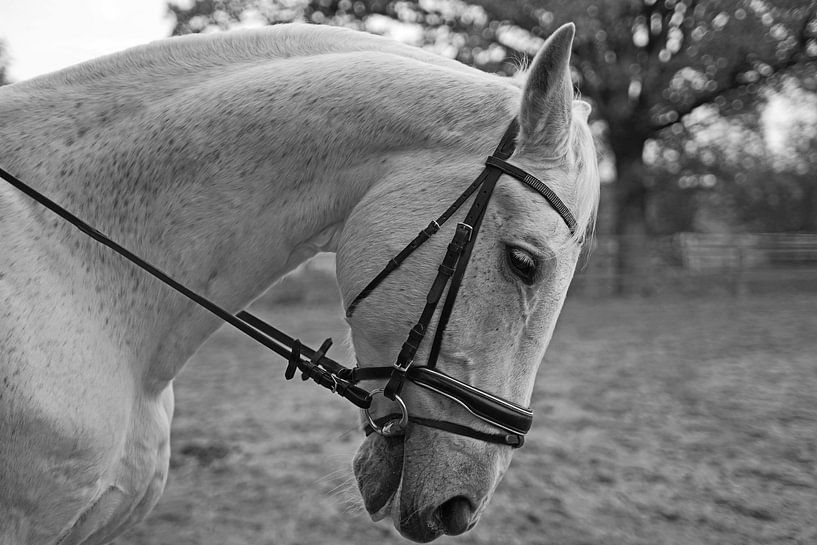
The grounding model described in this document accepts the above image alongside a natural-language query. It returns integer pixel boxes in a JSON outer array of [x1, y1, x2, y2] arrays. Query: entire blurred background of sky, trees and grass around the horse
[[0, 0, 817, 545]]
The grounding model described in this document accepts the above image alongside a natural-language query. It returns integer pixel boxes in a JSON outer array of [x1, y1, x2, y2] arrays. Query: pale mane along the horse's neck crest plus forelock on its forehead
[[13, 23, 599, 242]]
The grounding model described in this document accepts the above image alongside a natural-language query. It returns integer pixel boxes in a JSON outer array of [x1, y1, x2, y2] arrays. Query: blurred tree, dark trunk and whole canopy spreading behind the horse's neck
[[170, 0, 817, 292]]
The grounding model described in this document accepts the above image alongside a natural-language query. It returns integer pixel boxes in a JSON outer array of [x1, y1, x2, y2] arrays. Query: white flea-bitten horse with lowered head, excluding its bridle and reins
[[0, 24, 599, 545]]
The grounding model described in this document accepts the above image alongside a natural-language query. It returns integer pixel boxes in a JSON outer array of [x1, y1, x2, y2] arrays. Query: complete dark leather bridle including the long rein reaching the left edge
[[0, 120, 576, 448]]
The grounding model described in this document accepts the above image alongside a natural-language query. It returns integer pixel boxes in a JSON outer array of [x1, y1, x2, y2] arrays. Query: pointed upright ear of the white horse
[[519, 23, 576, 147]]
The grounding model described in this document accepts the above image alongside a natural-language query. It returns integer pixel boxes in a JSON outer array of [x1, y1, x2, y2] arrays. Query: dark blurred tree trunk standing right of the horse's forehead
[[610, 134, 654, 295]]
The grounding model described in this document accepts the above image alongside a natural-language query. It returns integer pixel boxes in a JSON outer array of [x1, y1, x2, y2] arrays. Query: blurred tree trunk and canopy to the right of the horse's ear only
[[540, 0, 817, 291]]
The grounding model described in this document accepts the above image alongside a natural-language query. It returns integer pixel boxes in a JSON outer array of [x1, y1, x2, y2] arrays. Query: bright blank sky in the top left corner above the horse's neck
[[0, 0, 173, 81]]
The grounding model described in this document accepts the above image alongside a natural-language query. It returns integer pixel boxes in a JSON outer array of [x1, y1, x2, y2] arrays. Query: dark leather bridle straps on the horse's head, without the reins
[[338, 119, 576, 447]]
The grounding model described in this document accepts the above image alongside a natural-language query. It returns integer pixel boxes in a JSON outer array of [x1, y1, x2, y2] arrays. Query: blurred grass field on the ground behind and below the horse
[[118, 274, 817, 545]]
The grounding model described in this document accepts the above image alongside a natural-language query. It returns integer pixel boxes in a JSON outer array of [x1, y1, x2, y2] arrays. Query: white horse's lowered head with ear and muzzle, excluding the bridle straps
[[337, 25, 598, 542]]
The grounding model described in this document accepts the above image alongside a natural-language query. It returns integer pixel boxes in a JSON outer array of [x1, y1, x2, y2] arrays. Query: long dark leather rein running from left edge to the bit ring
[[0, 167, 372, 409]]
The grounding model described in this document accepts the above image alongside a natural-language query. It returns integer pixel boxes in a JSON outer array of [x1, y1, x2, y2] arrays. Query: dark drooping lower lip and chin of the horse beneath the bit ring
[[352, 433, 405, 521]]
